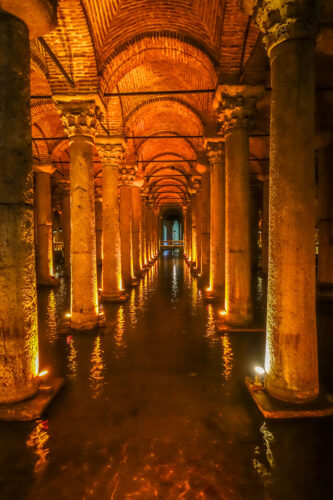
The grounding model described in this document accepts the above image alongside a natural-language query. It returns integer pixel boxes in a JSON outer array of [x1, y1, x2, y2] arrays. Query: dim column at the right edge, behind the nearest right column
[[318, 147, 333, 292]]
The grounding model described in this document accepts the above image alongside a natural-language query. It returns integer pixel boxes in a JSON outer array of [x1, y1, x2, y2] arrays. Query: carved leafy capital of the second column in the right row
[[213, 85, 264, 134]]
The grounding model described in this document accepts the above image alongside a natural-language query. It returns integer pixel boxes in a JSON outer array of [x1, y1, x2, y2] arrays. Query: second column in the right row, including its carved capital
[[215, 85, 262, 326]]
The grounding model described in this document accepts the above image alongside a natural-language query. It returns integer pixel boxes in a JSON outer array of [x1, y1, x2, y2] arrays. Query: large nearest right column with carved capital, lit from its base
[[254, 0, 319, 403]]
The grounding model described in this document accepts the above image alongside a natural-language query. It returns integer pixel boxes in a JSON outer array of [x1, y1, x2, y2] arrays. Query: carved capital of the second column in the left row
[[55, 96, 103, 141]]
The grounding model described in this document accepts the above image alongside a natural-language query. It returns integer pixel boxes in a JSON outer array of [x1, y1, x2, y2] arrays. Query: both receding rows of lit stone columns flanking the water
[[0, 1, 333, 412]]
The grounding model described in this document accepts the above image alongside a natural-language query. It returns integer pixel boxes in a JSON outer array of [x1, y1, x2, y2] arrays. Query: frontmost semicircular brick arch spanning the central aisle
[[101, 32, 217, 93]]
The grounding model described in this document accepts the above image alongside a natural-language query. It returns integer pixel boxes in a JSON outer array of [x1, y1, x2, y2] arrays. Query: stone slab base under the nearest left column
[[0, 377, 64, 422]]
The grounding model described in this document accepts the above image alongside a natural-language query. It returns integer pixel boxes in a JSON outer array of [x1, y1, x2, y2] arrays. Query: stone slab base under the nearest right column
[[245, 377, 333, 419]]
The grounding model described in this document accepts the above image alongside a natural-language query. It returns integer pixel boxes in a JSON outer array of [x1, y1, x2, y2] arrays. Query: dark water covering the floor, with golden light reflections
[[0, 252, 333, 500]]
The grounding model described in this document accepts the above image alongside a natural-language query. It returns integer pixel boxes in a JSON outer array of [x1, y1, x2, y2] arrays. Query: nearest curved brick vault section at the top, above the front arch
[[82, 0, 223, 71]]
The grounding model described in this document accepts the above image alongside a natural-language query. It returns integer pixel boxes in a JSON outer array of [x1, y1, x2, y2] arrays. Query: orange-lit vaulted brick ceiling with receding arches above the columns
[[31, 0, 332, 211]]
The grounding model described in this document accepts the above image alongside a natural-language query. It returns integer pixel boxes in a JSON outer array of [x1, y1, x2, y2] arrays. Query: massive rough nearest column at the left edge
[[0, 2, 55, 403]]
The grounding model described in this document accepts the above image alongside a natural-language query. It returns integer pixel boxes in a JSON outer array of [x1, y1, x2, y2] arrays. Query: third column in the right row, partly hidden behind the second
[[207, 140, 225, 296]]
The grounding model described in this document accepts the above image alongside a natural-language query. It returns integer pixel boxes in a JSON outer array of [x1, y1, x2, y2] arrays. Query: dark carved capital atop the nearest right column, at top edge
[[253, 0, 320, 55]]
